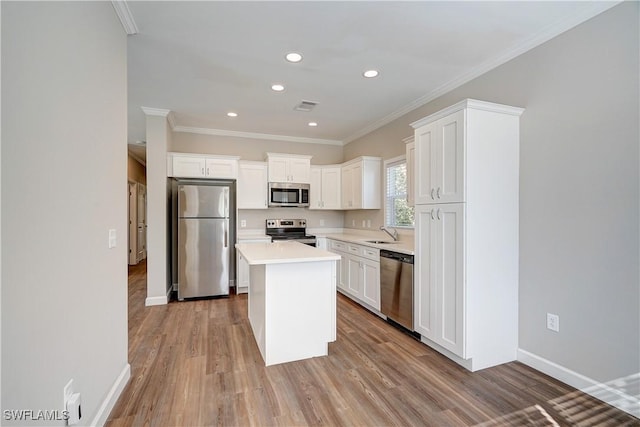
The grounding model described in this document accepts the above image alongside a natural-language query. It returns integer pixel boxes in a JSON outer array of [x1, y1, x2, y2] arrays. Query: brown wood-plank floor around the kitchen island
[[107, 264, 640, 427]]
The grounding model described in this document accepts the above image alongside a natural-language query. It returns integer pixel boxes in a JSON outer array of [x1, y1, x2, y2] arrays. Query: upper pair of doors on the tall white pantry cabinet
[[415, 110, 466, 204]]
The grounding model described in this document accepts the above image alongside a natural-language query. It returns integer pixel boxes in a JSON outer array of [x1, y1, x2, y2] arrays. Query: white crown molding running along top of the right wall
[[344, 1, 622, 145]]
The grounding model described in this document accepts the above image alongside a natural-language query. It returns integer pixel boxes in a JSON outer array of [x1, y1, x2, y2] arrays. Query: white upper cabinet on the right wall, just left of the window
[[342, 157, 382, 209]]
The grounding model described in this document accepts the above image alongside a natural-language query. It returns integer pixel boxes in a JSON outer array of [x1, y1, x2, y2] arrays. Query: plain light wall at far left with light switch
[[1, 2, 129, 425]]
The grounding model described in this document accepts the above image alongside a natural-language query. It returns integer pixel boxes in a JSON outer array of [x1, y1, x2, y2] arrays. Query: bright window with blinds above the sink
[[384, 156, 413, 227]]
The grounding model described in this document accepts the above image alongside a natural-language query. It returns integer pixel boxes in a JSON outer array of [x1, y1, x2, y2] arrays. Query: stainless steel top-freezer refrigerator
[[177, 182, 235, 301]]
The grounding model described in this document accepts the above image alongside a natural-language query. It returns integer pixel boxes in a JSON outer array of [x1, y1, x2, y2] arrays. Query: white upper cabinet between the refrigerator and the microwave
[[237, 160, 268, 209]]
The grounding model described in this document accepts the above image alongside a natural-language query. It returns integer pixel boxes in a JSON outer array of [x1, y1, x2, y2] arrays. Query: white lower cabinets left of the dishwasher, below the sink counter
[[329, 239, 380, 310]]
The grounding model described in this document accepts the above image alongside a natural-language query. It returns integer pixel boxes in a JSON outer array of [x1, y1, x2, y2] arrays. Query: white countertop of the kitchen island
[[236, 240, 340, 265]]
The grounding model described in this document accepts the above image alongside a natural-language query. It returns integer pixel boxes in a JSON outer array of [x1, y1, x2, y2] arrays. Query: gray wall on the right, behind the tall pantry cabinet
[[345, 2, 640, 382]]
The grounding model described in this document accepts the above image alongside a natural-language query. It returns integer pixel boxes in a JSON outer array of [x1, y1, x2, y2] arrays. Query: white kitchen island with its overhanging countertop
[[231, 241, 340, 366]]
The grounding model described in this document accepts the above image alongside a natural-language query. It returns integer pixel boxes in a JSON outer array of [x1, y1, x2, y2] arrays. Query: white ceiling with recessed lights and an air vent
[[127, 1, 616, 159]]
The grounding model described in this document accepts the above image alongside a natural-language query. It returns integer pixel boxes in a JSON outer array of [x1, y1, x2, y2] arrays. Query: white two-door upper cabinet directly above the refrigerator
[[167, 153, 239, 179]]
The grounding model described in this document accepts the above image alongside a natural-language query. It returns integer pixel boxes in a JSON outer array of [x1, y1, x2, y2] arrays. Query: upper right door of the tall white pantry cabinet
[[434, 110, 466, 203]]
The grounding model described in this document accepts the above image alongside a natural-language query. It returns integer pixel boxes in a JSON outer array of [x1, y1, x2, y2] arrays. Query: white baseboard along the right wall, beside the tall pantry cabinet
[[518, 349, 640, 418]]
